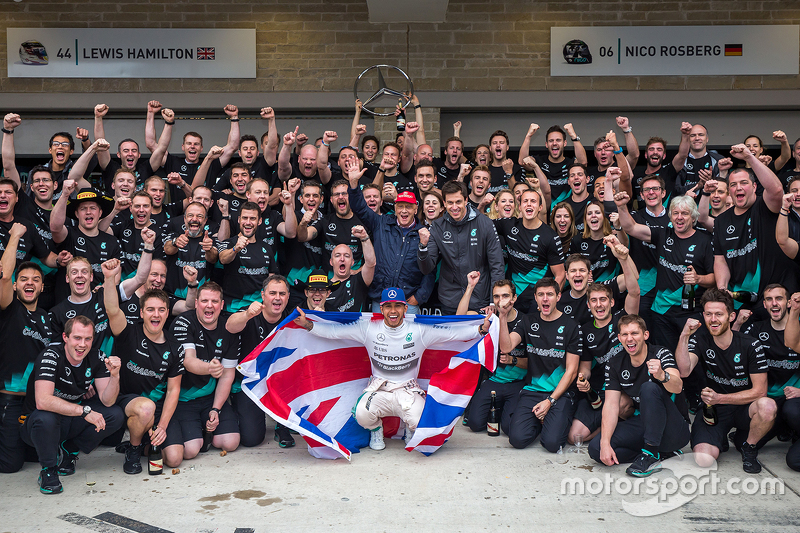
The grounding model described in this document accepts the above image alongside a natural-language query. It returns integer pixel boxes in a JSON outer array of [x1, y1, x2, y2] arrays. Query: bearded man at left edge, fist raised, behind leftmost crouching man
[[0, 227, 52, 473]]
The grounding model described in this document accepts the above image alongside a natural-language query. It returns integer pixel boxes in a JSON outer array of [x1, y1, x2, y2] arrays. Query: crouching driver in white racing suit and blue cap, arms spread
[[295, 287, 491, 450]]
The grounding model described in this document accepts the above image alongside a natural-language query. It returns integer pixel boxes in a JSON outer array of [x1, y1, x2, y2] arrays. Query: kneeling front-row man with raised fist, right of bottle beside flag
[[497, 278, 583, 453]]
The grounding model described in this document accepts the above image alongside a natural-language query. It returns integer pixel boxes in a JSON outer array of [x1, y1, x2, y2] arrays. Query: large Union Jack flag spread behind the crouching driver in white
[[239, 310, 499, 460]]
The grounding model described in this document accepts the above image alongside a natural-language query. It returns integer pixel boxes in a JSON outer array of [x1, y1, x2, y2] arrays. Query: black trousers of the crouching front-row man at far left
[[20, 396, 125, 468]]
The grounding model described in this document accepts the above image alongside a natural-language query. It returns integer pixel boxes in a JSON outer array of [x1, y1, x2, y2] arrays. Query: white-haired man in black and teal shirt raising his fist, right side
[[614, 192, 716, 353]]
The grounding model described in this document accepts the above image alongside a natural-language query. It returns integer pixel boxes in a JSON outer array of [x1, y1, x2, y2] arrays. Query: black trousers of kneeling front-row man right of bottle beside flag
[[508, 389, 576, 453]]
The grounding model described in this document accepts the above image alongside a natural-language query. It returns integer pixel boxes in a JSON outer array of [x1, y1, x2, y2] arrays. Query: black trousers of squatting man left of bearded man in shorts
[[589, 381, 689, 463]]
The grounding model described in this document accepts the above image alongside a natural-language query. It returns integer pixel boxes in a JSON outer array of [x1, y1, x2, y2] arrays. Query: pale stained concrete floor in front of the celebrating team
[[0, 424, 800, 533]]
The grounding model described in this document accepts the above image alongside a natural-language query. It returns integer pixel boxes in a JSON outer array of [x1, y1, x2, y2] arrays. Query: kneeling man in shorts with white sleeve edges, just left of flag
[[169, 281, 239, 466]]
